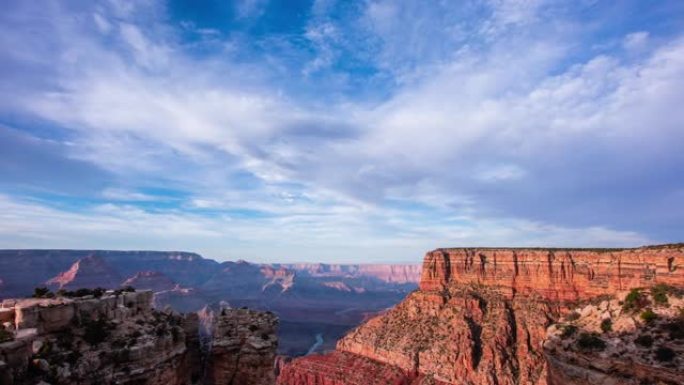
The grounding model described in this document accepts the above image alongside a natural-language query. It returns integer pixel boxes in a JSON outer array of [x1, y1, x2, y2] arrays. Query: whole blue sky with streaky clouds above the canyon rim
[[0, 0, 684, 263]]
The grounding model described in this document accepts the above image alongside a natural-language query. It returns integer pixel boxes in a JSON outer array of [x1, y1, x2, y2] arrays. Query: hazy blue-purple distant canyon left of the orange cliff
[[0, 250, 421, 356]]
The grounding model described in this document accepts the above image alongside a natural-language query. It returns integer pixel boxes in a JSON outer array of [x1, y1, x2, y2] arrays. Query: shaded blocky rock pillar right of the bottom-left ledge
[[204, 309, 278, 385]]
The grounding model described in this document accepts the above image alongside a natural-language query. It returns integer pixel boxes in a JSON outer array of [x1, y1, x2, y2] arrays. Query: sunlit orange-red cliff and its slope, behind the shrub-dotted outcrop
[[279, 245, 684, 385]]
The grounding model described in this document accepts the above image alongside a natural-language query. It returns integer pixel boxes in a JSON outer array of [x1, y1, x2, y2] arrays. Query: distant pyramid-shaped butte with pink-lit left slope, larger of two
[[45, 254, 121, 290]]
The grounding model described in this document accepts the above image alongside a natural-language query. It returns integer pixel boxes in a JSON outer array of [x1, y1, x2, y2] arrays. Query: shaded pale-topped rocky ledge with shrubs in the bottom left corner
[[0, 291, 193, 385]]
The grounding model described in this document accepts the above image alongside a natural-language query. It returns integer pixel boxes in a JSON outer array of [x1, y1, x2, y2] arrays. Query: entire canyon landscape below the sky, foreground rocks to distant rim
[[0, 244, 684, 385]]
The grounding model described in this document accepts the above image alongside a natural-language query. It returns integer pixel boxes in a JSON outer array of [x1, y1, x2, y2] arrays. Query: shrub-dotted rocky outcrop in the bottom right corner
[[544, 286, 684, 385]]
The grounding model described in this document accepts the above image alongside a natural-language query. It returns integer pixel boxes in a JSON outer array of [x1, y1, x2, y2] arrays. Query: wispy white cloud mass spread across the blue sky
[[0, 1, 684, 258]]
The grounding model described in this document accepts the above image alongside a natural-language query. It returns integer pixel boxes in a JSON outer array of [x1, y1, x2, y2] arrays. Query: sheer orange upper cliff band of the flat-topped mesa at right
[[420, 244, 684, 301]]
